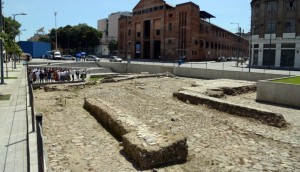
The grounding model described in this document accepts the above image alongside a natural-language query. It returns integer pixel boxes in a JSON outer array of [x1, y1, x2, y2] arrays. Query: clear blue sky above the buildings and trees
[[2, 0, 250, 41]]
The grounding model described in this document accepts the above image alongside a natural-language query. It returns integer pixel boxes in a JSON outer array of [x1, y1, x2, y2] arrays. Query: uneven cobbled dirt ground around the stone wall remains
[[34, 77, 300, 172]]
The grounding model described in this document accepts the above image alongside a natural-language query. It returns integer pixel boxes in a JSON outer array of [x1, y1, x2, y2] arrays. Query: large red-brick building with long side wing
[[118, 0, 249, 61]]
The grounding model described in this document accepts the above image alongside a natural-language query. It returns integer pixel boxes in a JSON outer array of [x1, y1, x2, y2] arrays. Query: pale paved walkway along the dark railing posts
[[0, 64, 37, 172]]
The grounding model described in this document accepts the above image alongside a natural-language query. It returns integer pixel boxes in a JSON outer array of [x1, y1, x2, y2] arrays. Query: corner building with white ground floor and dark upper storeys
[[251, 0, 300, 68]]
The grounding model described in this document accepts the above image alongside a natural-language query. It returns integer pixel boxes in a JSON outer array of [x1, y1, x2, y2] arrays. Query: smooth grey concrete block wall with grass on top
[[256, 77, 300, 108]]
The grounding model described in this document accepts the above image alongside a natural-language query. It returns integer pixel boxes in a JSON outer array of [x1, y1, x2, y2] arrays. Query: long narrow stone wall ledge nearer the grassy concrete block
[[173, 91, 287, 128]]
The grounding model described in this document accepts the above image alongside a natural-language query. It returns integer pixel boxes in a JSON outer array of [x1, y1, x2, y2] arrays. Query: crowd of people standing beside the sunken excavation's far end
[[28, 68, 86, 83]]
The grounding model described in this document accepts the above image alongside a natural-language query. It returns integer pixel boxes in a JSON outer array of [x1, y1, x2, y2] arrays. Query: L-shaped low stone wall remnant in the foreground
[[84, 99, 188, 170]]
